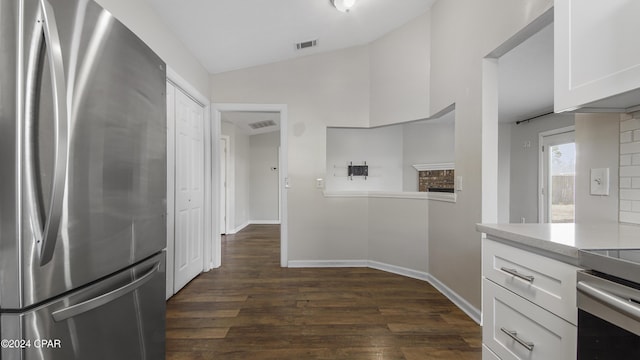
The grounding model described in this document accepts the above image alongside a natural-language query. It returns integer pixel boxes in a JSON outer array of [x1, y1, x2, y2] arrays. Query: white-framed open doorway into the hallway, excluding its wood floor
[[212, 104, 288, 267]]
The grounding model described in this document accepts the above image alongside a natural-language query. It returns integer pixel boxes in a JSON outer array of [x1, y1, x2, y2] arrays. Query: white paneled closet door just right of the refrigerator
[[174, 90, 204, 292]]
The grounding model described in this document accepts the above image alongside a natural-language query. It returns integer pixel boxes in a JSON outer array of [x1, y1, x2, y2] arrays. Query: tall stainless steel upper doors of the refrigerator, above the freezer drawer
[[0, 0, 166, 309]]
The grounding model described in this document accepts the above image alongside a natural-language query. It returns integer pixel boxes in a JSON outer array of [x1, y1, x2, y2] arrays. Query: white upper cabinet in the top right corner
[[554, 0, 640, 112]]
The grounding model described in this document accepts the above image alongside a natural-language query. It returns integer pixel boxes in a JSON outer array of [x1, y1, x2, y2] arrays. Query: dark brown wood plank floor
[[167, 225, 481, 360]]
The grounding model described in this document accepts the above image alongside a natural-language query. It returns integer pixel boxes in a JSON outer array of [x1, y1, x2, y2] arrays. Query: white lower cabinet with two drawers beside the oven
[[482, 239, 578, 360]]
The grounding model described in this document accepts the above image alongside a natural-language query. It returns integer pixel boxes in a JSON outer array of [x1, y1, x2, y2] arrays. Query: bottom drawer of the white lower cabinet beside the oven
[[482, 278, 577, 360]]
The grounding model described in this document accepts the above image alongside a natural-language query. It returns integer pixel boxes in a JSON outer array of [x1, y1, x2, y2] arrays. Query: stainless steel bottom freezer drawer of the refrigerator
[[0, 253, 165, 360]]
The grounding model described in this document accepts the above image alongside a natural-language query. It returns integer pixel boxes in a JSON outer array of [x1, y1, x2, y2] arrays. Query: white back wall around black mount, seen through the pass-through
[[326, 126, 402, 191]]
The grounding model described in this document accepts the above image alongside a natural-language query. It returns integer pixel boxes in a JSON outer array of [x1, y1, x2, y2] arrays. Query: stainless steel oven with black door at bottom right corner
[[577, 249, 640, 360]]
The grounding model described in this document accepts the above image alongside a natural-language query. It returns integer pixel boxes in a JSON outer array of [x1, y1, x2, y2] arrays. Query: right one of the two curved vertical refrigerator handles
[[34, 0, 68, 266]]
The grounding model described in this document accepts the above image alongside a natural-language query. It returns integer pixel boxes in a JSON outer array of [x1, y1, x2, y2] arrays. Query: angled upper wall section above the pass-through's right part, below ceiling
[[369, 12, 431, 126]]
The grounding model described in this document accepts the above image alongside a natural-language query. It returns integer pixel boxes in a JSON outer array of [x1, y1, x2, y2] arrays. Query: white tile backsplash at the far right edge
[[619, 112, 640, 224]]
